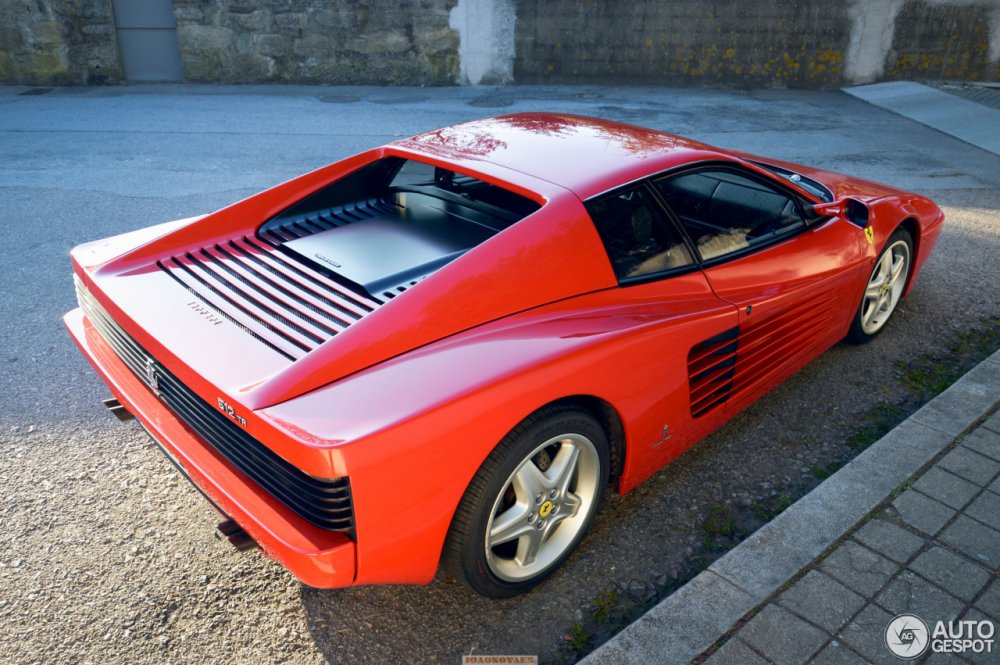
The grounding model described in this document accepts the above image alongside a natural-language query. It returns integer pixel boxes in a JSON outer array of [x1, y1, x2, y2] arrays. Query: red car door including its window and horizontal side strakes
[[654, 166, 869, 415]]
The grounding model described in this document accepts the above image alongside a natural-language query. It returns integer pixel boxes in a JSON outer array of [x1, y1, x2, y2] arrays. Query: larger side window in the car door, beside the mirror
[[655, 170, 805, 261]]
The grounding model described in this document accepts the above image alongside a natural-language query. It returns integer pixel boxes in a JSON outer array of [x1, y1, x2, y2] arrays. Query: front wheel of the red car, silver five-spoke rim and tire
[[847, 229, 913, 344]]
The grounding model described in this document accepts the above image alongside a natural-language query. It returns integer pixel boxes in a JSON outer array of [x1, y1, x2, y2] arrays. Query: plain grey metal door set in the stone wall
[[111, 0, 183, 81]]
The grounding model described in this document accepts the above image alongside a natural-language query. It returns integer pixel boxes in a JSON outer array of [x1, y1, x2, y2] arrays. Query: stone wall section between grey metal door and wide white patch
[[174, 0, 458, 85]]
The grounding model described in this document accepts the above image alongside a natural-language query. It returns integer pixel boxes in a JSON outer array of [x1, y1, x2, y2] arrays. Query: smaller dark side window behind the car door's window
[[587, 187, 693, 279]]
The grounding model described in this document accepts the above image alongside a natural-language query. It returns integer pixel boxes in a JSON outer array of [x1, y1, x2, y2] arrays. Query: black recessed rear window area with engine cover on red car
[[257, 157, 541, 300]]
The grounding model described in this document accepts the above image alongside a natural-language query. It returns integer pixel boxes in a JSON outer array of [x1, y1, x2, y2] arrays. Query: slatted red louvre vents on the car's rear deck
[[157, 236, 381, 360]]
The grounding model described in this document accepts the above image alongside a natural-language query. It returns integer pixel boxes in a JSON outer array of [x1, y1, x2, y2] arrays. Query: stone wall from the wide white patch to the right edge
[[513, 0, 1000, 88]]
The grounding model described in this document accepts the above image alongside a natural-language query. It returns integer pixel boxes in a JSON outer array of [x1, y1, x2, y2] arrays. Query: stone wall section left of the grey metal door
[[0, 0, 122, 85]]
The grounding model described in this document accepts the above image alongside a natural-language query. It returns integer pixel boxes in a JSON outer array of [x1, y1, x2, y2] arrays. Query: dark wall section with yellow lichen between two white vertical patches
[[514, 0, 851, 87]]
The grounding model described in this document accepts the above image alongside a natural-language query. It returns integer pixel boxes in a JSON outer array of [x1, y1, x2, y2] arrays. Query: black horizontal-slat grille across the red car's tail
[[76, 278, 354, 535]]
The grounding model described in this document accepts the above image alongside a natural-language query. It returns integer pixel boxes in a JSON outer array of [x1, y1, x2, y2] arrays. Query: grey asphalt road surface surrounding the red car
[[0, 86, 1000, 663]]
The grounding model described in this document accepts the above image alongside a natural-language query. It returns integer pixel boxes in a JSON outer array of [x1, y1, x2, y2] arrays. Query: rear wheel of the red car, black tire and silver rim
[[444, 405, 610, 598]]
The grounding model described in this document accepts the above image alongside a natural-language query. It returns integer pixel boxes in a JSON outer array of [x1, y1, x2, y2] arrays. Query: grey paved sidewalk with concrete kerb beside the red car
[[584, 352, 1000, 665]]
